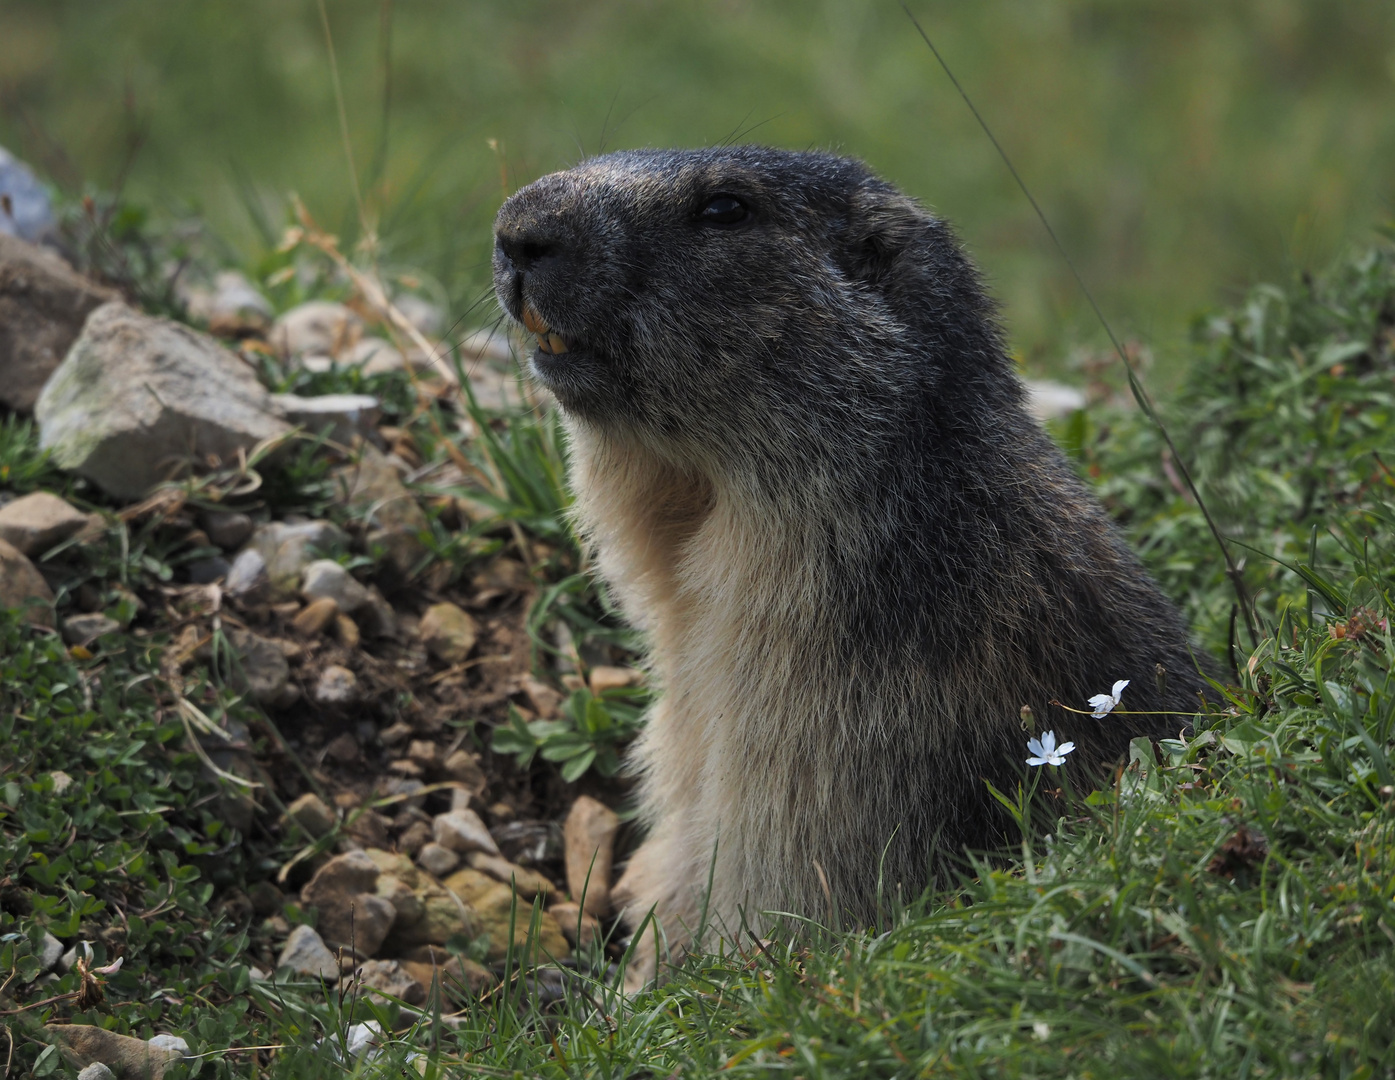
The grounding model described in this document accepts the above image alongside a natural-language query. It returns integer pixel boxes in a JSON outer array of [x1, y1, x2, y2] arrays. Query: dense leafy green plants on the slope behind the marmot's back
[[1057, 234, 1395, 650]]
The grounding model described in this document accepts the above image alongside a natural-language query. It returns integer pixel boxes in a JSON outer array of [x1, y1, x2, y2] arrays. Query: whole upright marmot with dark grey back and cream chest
[[494, 147, 1205, 974]]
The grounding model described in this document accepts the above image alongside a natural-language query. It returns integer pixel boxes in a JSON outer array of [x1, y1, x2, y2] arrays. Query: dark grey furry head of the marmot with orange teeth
[[494, 147, 1016, 460]]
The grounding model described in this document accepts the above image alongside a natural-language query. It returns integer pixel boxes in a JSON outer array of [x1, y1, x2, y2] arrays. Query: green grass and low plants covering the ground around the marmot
[[0, 196, 1395, 1080]]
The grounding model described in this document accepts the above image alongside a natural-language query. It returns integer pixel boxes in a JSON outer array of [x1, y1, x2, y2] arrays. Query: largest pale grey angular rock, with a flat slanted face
[[33, 303, 290, 498]]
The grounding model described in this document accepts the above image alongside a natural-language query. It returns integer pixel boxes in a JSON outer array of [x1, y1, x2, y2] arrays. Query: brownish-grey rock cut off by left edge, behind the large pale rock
[[0, 233, 119, 413]]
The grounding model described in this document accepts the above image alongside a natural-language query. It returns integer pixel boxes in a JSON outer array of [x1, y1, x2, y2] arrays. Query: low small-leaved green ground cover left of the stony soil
[[0, 613, 260, 1056]]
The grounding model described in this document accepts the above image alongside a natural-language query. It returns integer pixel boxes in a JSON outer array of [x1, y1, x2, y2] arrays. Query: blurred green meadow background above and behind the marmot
[[0, 0, 1395, 382]]
